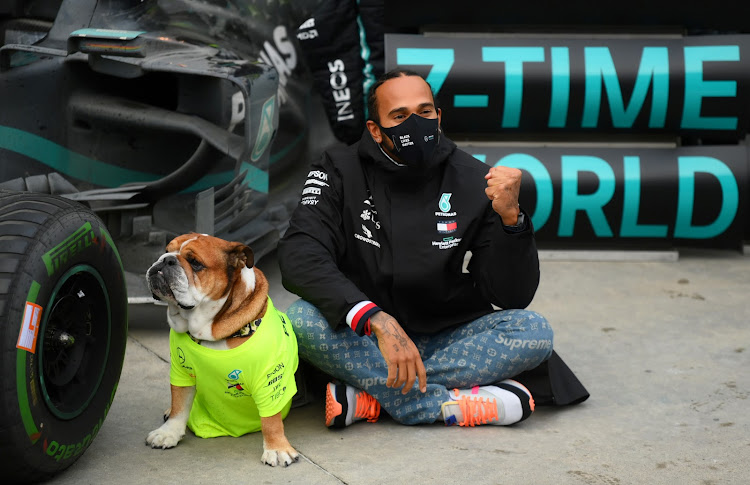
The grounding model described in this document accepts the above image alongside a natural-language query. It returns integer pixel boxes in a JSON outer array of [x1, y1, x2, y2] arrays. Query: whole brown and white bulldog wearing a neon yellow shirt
[[146, 234, 299, 466]]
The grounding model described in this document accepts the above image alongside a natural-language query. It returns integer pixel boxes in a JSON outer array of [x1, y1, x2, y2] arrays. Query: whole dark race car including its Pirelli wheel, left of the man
[[0, 0, 335, 481]]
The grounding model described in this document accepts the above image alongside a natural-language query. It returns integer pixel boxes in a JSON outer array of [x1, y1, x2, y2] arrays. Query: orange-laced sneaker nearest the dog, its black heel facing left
[[326, 382, 380, 428]]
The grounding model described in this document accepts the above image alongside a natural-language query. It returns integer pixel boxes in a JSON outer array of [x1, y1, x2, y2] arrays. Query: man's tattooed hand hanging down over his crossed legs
[[370, 311, 427, 394]]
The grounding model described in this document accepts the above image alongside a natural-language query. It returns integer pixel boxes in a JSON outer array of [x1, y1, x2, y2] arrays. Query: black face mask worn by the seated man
[[380, 114, 440, 169]]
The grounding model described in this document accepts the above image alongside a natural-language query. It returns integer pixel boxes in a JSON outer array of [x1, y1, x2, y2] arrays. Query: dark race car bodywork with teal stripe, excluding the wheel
[[0, 0, 334, 294]]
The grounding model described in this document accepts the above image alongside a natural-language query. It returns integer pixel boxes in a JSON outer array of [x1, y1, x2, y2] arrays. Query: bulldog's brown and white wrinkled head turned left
[[146, 233, 255, 340]]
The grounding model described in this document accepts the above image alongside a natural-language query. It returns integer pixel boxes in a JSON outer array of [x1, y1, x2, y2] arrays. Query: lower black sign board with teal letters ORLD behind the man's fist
[[461, 145, 748, 247]]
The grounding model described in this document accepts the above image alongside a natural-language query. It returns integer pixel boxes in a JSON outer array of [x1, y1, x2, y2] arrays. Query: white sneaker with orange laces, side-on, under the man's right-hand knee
[[441, 379, 534, 426]]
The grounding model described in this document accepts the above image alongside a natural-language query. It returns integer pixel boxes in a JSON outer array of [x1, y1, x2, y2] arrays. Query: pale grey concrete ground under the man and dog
[[51, 251, 750, 485]]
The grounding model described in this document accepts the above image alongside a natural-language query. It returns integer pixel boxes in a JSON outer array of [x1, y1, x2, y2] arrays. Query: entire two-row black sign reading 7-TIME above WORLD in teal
[[386, 34, 750, 248]]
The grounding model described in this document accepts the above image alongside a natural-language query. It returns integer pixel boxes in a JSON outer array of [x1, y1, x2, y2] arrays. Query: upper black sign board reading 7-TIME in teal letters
[[386, 34, 750, 140]]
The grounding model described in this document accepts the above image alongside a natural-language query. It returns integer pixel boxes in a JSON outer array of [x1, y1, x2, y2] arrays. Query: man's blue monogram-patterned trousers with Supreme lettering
[[286, 300, 553, 424]]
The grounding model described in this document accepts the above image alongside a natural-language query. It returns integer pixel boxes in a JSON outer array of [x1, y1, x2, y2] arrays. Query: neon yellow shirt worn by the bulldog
[[169, 298, 299, 438]]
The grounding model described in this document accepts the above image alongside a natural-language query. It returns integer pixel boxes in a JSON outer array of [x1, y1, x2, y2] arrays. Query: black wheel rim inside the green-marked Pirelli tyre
[[39, 265, 112, 419]]
